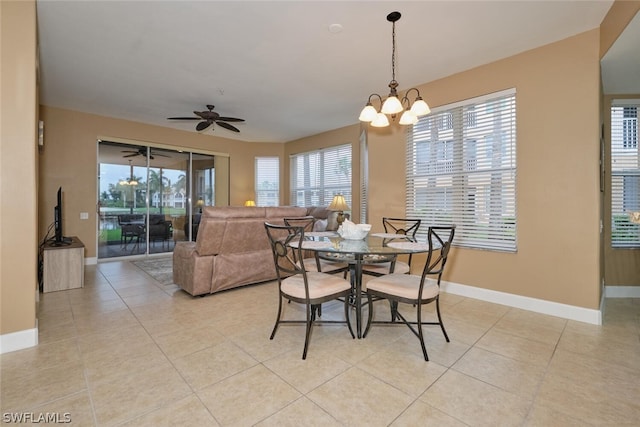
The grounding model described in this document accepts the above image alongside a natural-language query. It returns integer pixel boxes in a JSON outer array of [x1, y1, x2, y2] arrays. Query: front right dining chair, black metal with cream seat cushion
[[363, 225, 456, 361]]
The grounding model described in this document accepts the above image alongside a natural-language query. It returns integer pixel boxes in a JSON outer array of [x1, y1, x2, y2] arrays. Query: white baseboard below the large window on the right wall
[[441, 282, 602, 325]]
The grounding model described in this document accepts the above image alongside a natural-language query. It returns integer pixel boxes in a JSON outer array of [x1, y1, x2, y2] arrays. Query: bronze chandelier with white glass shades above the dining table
[[359, 12, 431, 127]]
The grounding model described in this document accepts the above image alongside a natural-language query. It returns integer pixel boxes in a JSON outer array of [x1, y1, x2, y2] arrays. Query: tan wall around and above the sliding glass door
[[38, 106, 283, 257]]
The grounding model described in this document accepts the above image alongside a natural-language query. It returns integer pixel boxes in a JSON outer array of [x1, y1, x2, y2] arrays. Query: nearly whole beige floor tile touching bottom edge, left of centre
[[197, 365, 301, 426]]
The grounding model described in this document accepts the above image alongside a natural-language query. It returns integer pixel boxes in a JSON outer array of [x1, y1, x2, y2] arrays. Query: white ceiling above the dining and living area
[[37, 0, 628, 142]]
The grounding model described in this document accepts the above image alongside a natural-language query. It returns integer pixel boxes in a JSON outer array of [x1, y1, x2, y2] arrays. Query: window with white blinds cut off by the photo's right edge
[[611, 100, 640, 248]]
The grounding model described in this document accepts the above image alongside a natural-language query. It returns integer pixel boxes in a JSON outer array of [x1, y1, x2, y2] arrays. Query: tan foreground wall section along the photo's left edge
[[0, 1, 38, 335]]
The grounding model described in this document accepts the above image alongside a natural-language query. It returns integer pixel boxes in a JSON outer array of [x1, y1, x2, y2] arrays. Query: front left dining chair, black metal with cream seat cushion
[[264, 223, 355, 360]]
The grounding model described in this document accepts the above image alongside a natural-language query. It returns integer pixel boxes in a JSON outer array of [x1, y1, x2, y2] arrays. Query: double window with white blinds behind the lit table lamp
[[290, 144, 352, 206]]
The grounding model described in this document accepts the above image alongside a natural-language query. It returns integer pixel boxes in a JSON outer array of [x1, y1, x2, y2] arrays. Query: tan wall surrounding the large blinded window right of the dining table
[[296, 30, 601, 309]]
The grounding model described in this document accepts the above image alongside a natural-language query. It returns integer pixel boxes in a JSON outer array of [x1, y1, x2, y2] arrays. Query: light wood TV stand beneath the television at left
[[42, 237, 84, 292]]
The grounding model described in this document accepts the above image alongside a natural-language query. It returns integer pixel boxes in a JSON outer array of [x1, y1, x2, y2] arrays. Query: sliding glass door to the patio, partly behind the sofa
[[98, 141, 228, 259]]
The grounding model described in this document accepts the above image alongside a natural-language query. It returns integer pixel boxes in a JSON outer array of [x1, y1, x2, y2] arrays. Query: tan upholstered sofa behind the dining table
[[173, 206, 337, 296]]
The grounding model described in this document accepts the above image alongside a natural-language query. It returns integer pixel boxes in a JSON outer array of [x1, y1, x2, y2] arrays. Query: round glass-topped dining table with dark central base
[[292, 232, 429, 338]]
